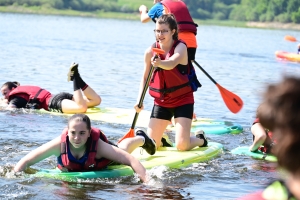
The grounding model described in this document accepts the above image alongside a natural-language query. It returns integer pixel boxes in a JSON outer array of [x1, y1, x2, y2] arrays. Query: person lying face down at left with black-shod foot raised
[[1, 63, 101, 113]]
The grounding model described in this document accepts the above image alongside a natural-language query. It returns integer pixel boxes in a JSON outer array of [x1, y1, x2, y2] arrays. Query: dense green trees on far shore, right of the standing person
[[185, 0, 300, 23]]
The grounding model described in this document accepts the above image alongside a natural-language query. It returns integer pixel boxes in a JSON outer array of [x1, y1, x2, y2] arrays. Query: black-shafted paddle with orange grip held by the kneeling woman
[[118, 48, 165, 143]]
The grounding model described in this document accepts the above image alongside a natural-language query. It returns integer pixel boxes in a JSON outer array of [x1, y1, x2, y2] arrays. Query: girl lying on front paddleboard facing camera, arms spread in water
[[14, 114, 156, 182]]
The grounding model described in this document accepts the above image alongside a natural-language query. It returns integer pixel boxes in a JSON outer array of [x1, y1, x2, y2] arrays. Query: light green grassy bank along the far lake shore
[[0, 0, 300, 30]]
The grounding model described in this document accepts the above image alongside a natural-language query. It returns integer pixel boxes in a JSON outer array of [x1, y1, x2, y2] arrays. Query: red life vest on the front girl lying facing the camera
[[57, 128, 111, 171]]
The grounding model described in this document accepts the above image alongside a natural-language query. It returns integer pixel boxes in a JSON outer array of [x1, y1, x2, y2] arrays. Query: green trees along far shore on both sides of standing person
[[0, 0, 300, 23]]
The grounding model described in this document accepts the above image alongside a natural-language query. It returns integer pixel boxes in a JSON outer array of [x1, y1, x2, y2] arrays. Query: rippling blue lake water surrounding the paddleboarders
[[0, 13, 300, 200]]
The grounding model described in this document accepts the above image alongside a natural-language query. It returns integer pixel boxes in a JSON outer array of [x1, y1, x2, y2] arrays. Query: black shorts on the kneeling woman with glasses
[[151, 104, 194, 121]]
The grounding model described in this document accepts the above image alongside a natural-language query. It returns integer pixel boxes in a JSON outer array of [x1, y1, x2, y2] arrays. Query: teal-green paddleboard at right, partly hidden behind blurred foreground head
[[231, 146, 277, 162]]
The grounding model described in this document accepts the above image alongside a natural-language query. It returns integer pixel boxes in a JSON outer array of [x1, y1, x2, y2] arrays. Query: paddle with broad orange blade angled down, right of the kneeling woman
[[193, 60, 244, 113]]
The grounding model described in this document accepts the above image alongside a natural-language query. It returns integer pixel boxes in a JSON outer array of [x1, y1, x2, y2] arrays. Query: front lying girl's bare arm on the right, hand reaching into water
[[96, 139, 147, 182]]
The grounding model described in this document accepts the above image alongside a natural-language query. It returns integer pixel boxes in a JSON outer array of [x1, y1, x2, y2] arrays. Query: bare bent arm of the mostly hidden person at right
[[249, 123, 267, 151]]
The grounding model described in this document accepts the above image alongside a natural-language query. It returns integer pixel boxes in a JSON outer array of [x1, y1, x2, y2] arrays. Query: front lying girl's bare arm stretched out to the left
[[14, 136, 61, 172]]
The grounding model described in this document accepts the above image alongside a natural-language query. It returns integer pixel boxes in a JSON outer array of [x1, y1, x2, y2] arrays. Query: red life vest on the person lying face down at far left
[[8, 86, 51, 110]]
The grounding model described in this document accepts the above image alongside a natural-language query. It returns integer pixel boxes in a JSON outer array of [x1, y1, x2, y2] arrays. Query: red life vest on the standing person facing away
[[161, 0, 198, 35]]
